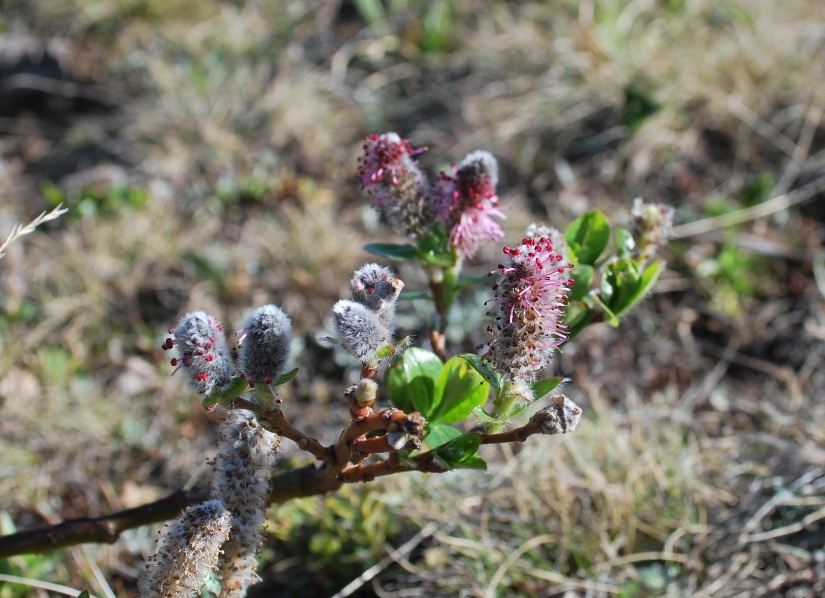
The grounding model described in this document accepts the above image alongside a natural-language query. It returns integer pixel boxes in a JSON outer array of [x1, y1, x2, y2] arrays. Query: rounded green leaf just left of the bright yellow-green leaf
[[386, 347, 443, 419]]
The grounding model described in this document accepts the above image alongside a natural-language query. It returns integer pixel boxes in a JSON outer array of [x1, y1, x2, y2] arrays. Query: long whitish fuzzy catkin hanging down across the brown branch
[[212, 409, 281, 598]]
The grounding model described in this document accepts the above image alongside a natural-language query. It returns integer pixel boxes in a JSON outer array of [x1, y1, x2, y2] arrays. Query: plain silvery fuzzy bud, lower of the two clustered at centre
[[332, 299, 392, 363]]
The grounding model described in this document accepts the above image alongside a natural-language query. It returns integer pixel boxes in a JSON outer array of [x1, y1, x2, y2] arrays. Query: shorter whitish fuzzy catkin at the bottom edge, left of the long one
[[138, 500, 232, 598]]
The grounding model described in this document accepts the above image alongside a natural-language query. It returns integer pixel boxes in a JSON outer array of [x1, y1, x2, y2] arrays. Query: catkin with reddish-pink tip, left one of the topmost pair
[[358, 133, 433, 237]]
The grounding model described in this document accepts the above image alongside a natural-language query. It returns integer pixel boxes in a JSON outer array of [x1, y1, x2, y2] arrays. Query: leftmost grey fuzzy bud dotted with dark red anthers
[[162, 311, 232, 395]]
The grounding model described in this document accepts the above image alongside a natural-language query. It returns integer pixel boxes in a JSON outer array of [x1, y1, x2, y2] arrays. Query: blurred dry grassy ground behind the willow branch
[[0, 0, 825, 598]]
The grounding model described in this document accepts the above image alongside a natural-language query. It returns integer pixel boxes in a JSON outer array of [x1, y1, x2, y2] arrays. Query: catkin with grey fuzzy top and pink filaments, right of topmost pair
[[435, 151, 505, 258]]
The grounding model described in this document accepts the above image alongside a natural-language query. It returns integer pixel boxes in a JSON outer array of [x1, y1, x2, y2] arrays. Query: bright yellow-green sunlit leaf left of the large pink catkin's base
[[427, 357, 490, 424]]
